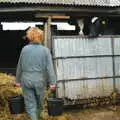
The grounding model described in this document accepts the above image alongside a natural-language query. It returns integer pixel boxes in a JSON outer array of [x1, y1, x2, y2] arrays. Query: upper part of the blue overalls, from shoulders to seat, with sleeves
[[16, 43, 56, 87]]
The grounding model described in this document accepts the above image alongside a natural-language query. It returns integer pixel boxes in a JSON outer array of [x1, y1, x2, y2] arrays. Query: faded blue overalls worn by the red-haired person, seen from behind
[[16, 43, 56, 120]]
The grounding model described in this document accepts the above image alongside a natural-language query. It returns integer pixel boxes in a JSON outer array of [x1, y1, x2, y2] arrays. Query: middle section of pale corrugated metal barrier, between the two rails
[[56, 57, 113, 80]]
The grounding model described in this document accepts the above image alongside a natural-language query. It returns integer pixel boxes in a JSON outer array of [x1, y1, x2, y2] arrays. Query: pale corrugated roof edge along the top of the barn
[[0, 0, 120, 7]]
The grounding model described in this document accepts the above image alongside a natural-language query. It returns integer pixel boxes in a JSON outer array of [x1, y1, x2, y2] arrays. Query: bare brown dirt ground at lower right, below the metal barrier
[[67, 106, 120, 120]]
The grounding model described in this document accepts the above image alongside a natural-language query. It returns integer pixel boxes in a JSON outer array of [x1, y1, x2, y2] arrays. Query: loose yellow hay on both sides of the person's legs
[[0, 73, 69, 120]]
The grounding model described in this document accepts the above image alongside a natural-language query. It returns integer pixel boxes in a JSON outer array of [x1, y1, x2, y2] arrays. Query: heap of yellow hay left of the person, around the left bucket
[[0, 73, 29, 120]]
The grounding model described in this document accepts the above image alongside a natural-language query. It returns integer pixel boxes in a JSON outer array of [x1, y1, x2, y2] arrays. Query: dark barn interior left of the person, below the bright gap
[[0, 30, 27, 74]]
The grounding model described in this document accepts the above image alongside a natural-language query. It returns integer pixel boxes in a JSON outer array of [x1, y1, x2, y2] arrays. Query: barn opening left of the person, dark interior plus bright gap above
[[0, 22, 43, 75]]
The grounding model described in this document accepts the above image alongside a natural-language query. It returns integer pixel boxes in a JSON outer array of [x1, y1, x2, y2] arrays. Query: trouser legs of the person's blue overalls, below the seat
[[22, 86, 44, 120]]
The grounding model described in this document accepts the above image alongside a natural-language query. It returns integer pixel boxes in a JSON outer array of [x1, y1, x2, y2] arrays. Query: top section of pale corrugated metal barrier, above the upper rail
[[54, 37, 112, 57]]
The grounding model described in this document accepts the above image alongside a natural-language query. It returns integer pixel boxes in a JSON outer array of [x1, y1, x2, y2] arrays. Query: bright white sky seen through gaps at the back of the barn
[[1, 22, 75, 30]]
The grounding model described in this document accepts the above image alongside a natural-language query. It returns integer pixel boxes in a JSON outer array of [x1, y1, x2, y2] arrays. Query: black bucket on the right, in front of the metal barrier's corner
[[47, 98, 63, 116]]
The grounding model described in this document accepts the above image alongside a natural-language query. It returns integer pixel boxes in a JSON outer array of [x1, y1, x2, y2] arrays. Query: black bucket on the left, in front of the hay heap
[[8, 95, 25, 114]]
